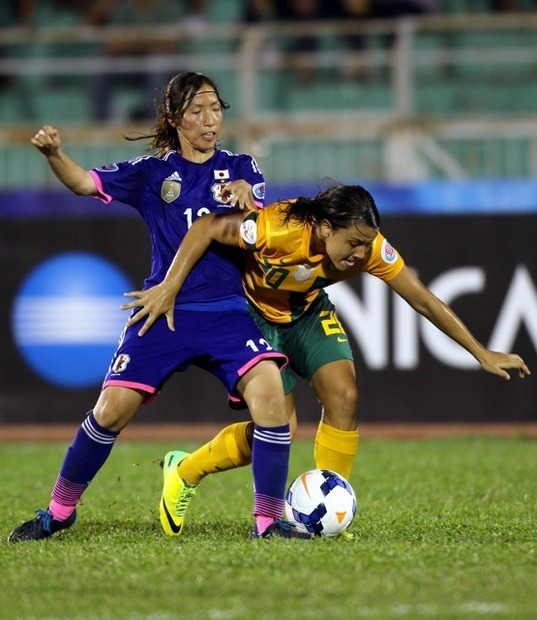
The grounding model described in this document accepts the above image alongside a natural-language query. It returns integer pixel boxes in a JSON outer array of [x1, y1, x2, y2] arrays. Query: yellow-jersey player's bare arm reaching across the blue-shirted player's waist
[[121, 213, 244, 336]]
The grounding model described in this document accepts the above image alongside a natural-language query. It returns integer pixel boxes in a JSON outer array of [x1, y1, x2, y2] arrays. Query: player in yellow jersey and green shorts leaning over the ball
[[124, 185, 530, 532]]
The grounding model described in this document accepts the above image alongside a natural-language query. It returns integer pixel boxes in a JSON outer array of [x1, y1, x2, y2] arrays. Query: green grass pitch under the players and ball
[[0, 437, 537, 620]]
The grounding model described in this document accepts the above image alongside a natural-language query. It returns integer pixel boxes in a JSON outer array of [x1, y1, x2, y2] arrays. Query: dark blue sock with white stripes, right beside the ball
[[252, 424, 291, 519]]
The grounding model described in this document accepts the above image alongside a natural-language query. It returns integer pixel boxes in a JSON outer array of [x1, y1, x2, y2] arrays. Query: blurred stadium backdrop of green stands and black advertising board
[[0, 0, 537, 423]]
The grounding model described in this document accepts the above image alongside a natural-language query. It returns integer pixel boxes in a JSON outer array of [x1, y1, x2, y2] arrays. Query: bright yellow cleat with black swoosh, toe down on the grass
[[160, 450, 198, 536]]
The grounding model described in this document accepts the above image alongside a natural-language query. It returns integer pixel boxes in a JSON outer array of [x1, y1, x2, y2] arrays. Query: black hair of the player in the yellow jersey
[[284, 184, 380, 229]]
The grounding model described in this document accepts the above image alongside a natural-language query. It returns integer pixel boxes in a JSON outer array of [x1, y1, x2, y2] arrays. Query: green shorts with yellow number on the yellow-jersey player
[[250, 290, 353, 394]]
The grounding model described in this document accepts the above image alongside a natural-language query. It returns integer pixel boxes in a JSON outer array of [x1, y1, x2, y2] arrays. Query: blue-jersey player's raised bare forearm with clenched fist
[[31, 125, 97, 196]]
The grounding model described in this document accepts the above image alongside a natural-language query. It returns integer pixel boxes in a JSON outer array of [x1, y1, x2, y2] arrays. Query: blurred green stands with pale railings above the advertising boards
[[0, 13, 537, 188]]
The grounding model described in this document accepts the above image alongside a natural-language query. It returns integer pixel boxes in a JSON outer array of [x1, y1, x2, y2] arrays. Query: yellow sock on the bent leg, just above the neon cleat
[[178, 422, 253, 485]]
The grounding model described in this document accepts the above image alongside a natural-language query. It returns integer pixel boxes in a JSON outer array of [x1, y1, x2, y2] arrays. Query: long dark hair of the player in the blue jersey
[[126, 71, 229, 156]]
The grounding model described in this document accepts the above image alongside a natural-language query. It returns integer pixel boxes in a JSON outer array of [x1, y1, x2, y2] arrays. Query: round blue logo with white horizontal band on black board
[[12, 252, 133, 388]]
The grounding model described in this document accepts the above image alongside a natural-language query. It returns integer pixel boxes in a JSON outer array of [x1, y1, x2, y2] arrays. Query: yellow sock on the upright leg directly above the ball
[[313, 422, 360, 480]]
